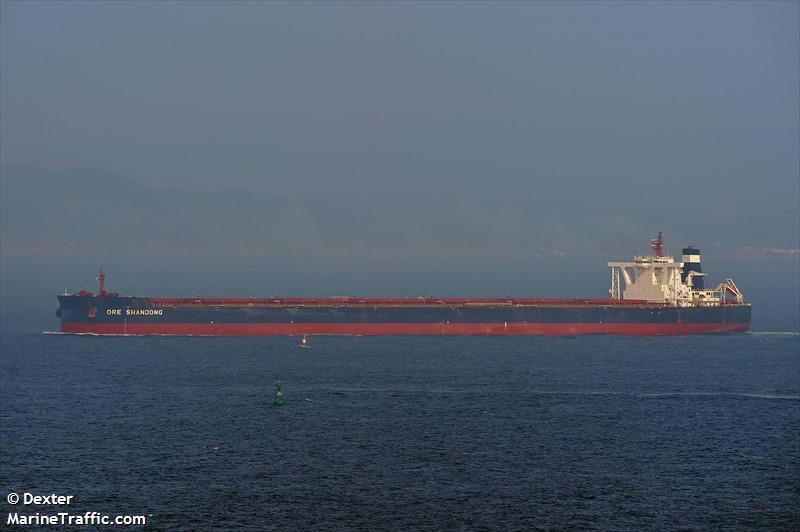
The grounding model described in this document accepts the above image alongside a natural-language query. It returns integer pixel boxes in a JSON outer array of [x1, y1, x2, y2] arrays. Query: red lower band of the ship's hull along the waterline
[[61, 323, 750, 336]]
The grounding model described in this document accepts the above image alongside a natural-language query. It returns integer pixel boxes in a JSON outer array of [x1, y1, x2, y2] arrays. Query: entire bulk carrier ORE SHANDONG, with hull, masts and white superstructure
[[56, 233, 751, 336]]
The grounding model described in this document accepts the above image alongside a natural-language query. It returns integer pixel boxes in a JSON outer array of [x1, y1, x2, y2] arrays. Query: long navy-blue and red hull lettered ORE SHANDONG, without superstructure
[[57, 295, 750, 336]]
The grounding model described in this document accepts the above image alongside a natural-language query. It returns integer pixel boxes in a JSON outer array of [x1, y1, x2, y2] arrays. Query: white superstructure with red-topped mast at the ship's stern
[[608, 232, 744, 307]]
